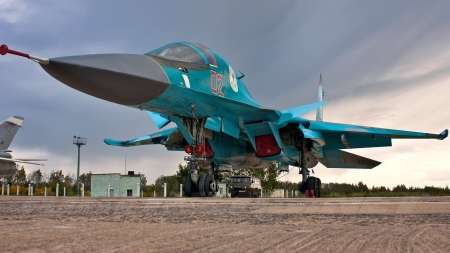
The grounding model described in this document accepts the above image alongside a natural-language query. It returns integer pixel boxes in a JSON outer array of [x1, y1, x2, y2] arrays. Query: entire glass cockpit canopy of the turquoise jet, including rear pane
[[148, 42, 218, 66]]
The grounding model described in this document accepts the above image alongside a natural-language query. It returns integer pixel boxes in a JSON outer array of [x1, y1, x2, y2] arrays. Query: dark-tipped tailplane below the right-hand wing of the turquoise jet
[[319, 150, 381, 169]]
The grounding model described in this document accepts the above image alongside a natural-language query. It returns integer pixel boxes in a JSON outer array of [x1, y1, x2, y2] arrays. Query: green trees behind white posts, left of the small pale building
[[2, 166, 92, 196]]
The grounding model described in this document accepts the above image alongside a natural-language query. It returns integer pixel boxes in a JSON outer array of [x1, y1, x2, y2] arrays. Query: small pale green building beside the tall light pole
[[91, 171, 141, 197]]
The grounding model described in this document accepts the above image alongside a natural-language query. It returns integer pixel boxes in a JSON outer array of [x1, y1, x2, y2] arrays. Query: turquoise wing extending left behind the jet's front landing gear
[[103, 127, 177, 147]]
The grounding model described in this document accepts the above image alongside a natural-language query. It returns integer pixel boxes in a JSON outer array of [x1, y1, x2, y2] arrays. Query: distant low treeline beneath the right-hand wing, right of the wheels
[[322, 182, 450, 198]]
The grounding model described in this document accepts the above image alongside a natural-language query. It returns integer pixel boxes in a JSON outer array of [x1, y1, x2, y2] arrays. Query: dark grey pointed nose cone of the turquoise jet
[[41, 54, 170, 105]]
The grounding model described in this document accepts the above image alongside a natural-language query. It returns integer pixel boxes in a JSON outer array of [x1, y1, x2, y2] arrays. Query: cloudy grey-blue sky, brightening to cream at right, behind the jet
[[0, 0, 450, 187]]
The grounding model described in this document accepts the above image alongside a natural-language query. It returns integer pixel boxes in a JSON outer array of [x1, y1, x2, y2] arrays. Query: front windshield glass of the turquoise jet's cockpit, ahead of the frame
[[151, 44, 205, 64]]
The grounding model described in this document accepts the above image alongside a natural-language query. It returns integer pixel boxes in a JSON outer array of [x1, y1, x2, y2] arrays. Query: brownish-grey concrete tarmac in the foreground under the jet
[[0, 196, 450, 252]]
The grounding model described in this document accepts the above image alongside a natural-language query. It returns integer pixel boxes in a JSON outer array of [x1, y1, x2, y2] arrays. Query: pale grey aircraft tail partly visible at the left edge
[[0, 116, 47, 178]]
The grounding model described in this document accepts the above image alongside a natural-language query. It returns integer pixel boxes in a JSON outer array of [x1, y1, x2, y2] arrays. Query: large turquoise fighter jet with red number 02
[[0, 42, 448, 197]]
